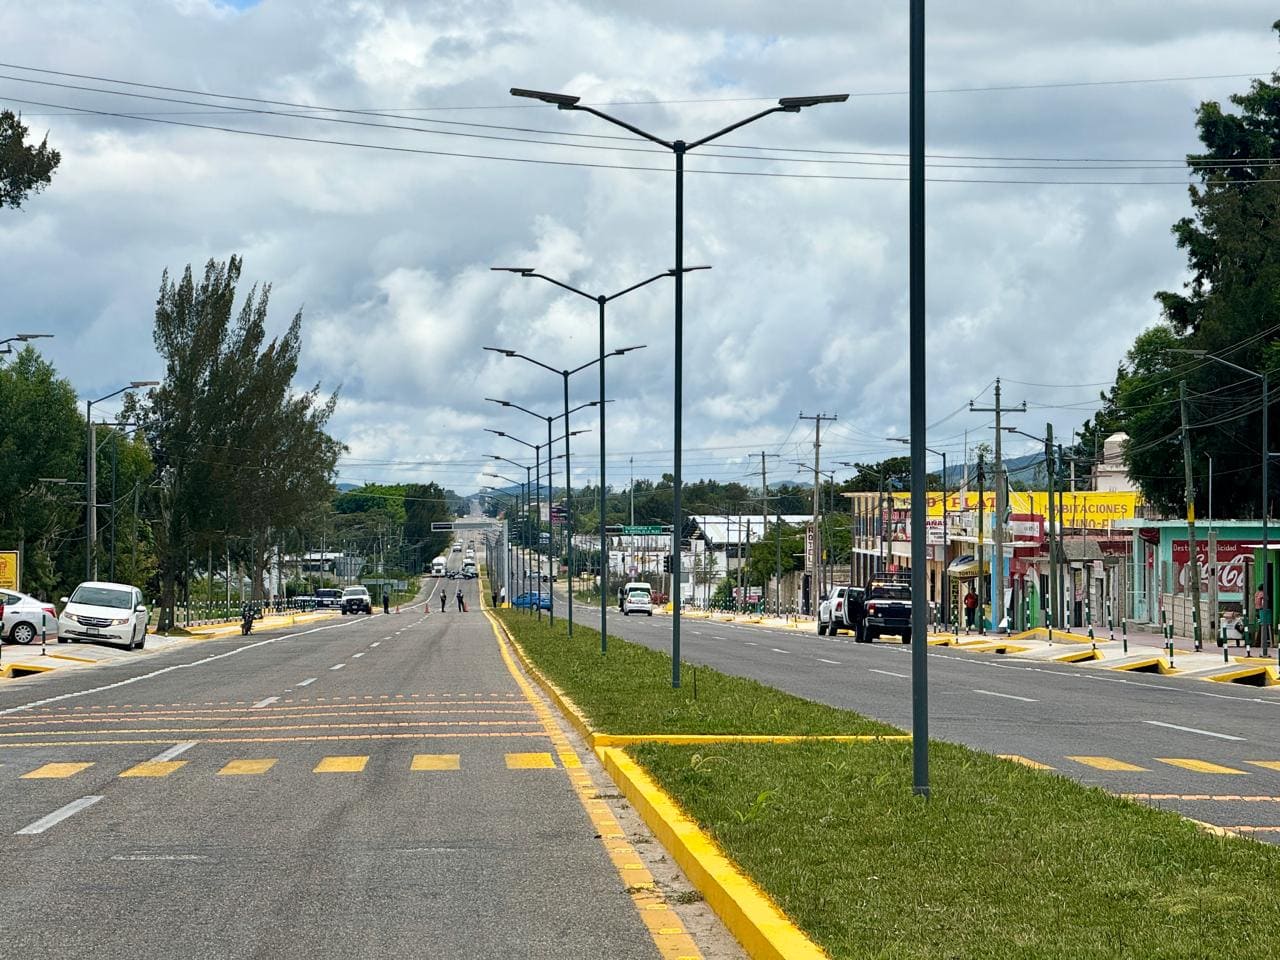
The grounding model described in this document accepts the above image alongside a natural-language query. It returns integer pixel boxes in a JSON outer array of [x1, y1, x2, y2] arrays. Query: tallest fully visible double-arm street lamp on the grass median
[[511, 80, 849, 687]]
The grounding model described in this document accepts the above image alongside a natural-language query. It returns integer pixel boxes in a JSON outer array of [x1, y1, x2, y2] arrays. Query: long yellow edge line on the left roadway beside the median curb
[[480, 611, 703, 960]]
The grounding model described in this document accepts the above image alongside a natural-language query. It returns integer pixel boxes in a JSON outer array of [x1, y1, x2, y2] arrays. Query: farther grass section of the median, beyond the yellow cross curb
[[497, 609, 901, 735]]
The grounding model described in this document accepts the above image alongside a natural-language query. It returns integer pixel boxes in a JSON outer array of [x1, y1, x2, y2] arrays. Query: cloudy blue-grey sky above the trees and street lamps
[[0, 0, 1277, 493]]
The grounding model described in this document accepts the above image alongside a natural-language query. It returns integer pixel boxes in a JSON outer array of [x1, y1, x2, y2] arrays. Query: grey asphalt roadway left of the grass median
[[0, 568, 721, 960]]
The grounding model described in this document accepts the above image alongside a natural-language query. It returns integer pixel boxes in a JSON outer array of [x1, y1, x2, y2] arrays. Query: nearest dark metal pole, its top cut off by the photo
[[908, 0, 931, 797]]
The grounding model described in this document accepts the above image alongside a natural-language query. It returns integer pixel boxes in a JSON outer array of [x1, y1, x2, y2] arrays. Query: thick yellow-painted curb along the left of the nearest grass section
[[596, 746, 827, 960]]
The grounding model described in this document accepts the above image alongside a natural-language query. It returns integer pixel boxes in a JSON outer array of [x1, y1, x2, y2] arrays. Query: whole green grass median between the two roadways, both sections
[[491, 611, 1280, 960]]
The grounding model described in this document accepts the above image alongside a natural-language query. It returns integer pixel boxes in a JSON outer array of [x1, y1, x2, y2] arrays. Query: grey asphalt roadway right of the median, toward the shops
[[576, 603, 1280, 842]]
